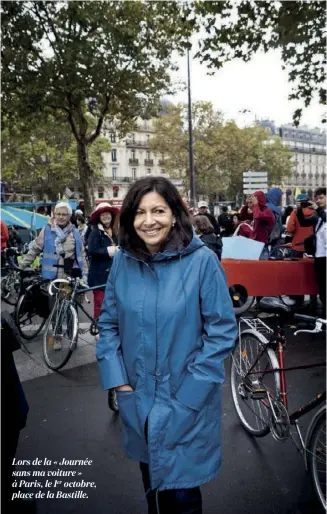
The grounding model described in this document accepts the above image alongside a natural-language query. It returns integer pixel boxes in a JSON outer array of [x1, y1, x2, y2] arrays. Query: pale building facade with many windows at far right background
[[260, 120, 326, 205]]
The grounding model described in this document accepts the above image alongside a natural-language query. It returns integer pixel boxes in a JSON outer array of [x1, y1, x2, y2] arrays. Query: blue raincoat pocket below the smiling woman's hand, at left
[[117, 391, 144, 452]]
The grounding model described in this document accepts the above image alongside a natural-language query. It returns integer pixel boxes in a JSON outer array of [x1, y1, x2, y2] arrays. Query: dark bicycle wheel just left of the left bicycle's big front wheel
[[15, 290, 46, 340]]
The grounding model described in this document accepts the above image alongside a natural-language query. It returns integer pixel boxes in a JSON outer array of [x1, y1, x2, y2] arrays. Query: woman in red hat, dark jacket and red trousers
[[87, 202, 119, 319]]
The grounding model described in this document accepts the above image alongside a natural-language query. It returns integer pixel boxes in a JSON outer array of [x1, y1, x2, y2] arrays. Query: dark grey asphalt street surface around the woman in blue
[[10, 308, 325, 514]]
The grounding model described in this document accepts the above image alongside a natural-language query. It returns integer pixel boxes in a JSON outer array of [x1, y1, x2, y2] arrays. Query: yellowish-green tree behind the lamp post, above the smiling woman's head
[[151, 102, 292, 200]]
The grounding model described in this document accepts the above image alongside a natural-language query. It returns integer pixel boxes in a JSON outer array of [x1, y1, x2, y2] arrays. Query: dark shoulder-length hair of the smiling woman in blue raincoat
[[119, 177, 193, 257]]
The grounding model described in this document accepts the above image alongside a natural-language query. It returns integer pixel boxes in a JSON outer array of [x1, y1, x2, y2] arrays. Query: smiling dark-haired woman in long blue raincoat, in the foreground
[[96, 177, 237, 508]]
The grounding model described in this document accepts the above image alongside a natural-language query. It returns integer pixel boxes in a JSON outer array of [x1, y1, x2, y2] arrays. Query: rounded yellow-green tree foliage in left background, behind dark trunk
[[1, 113, 110, 200]]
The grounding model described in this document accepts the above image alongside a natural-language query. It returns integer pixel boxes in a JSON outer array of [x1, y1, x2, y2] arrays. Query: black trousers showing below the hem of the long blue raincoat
[[140, 462, 202, 514]]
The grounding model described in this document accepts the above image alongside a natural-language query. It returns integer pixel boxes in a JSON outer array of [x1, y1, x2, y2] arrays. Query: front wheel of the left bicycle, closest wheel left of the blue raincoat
[[43, 299, 78, 370]]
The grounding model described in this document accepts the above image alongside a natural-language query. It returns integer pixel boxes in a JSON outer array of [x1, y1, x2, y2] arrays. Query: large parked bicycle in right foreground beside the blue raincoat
[[231, 298, 326, 509]]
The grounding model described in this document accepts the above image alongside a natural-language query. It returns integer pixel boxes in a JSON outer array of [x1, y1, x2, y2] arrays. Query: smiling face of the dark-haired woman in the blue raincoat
[[134, 191, 175, 254]]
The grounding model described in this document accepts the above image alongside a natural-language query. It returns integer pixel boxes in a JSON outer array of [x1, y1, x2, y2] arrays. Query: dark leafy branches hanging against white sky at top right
[[193, 0, 326, 124]]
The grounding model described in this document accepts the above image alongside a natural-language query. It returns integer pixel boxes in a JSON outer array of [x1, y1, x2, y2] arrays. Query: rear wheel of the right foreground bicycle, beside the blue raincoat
[[231, 330, 280, 437]]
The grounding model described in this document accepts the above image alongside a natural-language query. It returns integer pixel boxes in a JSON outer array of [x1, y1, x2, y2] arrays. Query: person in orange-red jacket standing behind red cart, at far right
[[286, 193, 313, 258]]
